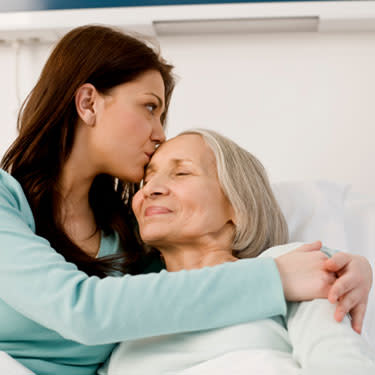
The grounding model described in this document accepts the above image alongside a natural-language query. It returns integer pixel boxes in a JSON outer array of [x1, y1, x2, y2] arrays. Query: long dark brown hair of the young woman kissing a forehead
[[1, 25, 174, 277]]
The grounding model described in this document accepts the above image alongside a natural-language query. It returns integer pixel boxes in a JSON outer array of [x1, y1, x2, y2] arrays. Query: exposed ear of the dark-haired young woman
[[75, 83, 100, 126]]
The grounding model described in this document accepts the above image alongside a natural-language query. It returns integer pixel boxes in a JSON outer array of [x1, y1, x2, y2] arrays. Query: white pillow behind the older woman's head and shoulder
[[272, 181, 375, 350]]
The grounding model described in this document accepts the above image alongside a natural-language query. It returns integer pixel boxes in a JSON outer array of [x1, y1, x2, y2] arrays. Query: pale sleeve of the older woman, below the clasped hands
[[287, 299, 375, 375]]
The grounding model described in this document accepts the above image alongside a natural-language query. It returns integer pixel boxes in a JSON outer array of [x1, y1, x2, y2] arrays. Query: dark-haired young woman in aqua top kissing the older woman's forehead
[[0, 26, 370, 375]]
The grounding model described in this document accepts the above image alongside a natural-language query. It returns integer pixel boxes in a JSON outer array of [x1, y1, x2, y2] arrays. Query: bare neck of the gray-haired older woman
[[159, 245, 237, 272]]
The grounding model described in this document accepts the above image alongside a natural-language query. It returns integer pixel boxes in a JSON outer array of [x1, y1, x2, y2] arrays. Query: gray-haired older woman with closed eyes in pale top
[[103, 130, 375, 375]]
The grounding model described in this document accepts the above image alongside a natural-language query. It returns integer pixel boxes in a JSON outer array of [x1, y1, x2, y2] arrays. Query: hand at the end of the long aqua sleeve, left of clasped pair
[[275, 241, 336, 302]]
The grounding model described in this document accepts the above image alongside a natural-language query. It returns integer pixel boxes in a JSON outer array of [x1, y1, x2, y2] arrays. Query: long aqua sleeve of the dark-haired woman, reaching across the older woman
[[0, 172, 286, 345]]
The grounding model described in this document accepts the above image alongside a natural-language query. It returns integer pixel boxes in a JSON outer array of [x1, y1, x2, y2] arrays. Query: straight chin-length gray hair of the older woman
[[179, 129, 288, 258]]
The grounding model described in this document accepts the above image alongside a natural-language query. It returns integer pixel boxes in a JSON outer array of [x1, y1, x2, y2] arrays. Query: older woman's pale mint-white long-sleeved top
[[104, 243, 375, 375]]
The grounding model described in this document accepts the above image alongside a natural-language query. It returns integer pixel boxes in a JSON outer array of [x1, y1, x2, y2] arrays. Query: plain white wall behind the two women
[[0, 33, 375, 193]]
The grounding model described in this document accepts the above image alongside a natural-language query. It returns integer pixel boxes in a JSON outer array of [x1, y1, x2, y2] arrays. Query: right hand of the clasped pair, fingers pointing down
[[324, 252, 373, 333]]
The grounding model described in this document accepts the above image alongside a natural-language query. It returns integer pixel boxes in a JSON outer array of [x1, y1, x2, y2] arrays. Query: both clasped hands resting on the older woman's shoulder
[[275, 241, 373, 333]]
